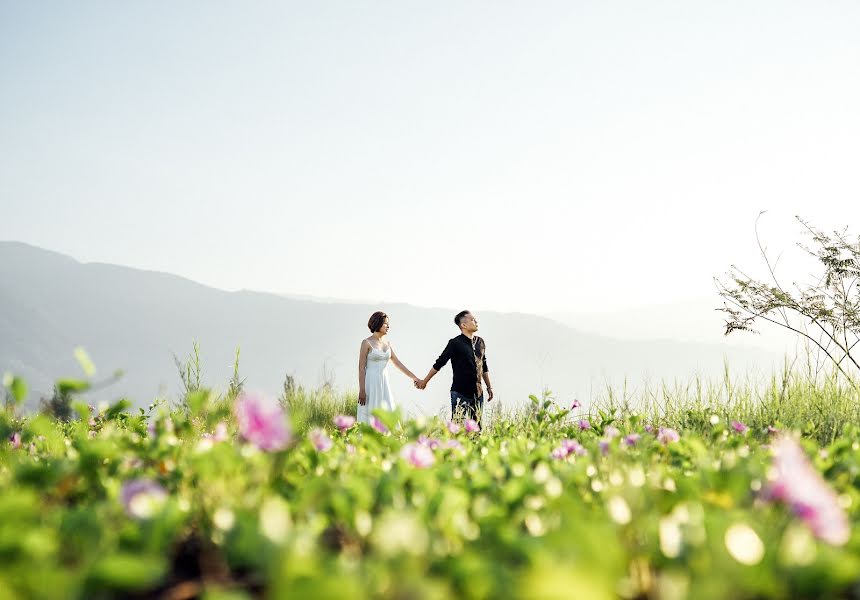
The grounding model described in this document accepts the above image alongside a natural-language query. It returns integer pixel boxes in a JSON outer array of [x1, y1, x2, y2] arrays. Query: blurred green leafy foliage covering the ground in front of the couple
[[0, 368, 860, 599]]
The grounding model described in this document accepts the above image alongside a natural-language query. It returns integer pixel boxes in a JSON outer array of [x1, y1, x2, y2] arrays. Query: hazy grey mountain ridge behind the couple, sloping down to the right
[[0, 242, 781, 414]]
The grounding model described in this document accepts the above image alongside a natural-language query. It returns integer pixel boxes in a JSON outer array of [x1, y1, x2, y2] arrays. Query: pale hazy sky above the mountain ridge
[[0, 0, 860, 312]]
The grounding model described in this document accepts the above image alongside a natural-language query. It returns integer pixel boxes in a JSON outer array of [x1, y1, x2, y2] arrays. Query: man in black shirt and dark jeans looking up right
[[415, 310, 493, 423]]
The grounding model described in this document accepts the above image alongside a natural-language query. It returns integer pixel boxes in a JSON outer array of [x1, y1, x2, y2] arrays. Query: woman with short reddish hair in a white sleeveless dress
[[357, 311, 418, 423]]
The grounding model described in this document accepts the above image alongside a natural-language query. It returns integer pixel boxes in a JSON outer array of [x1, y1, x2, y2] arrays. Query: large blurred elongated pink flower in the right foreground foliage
[[766, 437, 851, 546]]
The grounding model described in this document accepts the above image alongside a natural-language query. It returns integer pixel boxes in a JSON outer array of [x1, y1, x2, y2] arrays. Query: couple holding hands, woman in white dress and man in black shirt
[[357, 310, 493, 423]]
